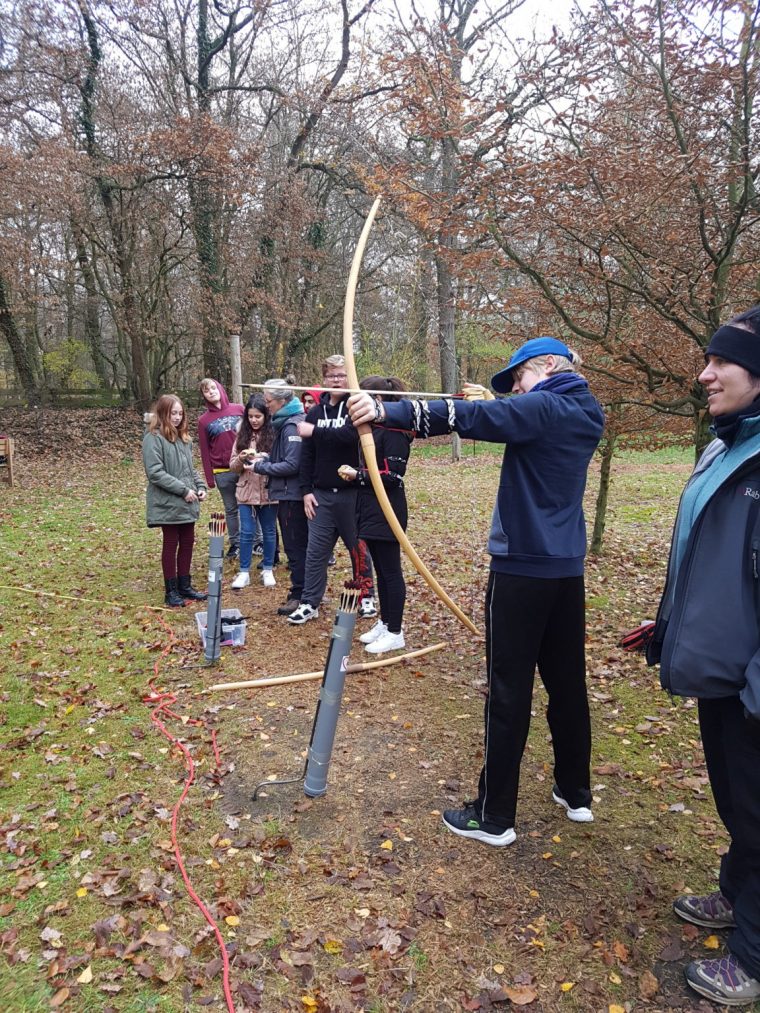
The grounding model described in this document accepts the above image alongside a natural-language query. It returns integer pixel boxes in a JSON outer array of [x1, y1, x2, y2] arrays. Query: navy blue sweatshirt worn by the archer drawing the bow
[[384, 373, 604, 578]]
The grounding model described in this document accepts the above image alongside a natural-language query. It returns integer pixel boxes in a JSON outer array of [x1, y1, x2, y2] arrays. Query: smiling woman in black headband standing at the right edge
[[647, 306, 760, 1006]]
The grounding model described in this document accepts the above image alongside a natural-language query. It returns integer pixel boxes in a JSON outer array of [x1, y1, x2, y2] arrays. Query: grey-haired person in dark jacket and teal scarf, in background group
[[253, 380, 309, 616]]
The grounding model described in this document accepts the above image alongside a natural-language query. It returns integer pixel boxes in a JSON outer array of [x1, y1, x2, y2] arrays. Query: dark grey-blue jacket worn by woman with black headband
[[647, 416, 760, 719]]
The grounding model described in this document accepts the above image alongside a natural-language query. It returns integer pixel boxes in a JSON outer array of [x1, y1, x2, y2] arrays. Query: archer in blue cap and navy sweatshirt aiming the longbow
[[349, 337, 604, 848]]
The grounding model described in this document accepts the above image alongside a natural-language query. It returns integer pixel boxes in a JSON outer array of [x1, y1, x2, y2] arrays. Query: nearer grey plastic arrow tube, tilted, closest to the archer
[[303, 611, 357, 798]]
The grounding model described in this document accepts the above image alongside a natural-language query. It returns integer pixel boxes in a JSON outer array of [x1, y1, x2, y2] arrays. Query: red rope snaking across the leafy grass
[[143, 616, 235, 1013]]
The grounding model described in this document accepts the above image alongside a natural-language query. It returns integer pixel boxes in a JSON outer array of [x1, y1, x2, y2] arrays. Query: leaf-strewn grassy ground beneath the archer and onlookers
[[0, 411, 727, 1013]]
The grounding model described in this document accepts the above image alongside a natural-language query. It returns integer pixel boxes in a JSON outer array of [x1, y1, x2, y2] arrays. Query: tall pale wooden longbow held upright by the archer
[[344, 197, 480, 636]]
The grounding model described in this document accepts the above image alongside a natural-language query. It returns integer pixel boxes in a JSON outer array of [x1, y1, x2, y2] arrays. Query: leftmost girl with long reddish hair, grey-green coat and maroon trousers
[[143, 394, 208, 609]]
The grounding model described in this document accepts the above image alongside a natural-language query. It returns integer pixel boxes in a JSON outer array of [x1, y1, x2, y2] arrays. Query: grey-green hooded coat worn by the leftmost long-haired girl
[[143, 433, 206, 528]]
